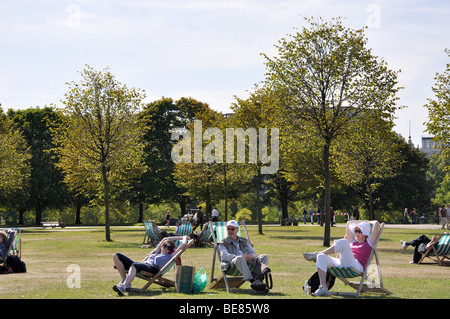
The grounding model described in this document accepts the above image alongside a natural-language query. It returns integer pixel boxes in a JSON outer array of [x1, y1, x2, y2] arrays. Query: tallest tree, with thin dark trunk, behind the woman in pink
[[264, 19, 398, 246]]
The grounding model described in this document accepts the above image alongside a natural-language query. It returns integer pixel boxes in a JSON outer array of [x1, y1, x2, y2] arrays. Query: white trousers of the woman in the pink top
[[316, 238, 364, 272]]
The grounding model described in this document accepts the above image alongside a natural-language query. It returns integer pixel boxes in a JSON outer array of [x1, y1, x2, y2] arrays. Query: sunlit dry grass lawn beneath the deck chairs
[[0, 225, 450, 300]]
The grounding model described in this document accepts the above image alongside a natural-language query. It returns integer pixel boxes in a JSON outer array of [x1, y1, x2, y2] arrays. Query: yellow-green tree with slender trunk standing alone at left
[[53, 66, 145, 241]]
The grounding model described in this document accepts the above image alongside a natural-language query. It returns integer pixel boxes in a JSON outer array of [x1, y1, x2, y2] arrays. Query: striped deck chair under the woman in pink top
[[328, 220, 391, 297]]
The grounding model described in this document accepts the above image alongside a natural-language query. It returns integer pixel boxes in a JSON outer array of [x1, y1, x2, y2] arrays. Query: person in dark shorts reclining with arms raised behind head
[[113, 236, 188, 296]]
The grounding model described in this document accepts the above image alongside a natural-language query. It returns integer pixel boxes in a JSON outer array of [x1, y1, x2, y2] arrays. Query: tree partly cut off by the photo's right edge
[[425, 49, 450, 169]]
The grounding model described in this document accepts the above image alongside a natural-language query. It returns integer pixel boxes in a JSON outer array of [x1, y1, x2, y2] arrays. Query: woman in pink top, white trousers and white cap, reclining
[[303, 222, 373, 297]]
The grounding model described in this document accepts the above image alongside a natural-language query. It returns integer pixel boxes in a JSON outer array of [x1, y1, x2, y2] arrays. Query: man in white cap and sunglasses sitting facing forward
[[219, 220, 269, 290]]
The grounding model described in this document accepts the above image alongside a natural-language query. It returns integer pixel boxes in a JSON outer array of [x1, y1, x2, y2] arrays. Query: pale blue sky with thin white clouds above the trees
[[0, 0, 450, 146]]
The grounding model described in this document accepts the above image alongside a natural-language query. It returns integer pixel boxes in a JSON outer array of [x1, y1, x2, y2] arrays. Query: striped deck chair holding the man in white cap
[[208, 222, 251, 293]]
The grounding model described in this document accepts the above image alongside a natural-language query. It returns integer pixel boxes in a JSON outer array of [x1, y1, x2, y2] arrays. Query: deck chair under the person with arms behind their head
[[136, 236, 194, 292]]
